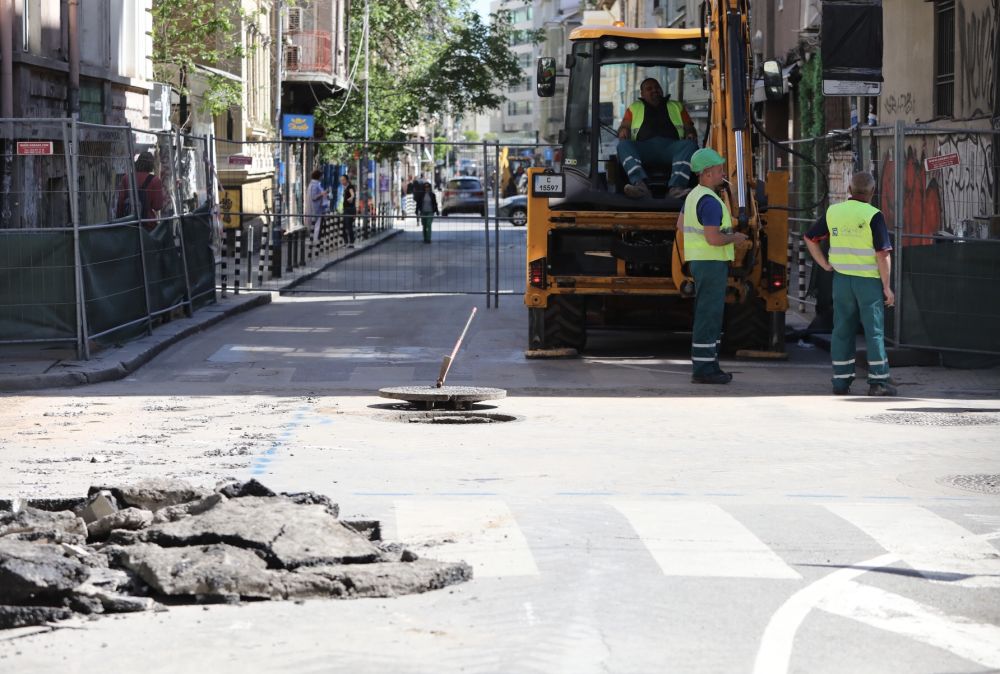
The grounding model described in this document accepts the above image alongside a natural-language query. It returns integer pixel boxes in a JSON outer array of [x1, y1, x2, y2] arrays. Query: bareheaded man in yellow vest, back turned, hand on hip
[[805, 171, 896, 396]]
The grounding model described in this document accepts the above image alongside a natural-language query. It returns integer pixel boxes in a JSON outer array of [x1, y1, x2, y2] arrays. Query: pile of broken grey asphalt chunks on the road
[[0, 480, 472, 629]]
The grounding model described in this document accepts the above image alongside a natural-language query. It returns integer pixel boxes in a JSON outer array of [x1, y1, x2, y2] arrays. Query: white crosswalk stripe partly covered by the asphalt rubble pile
[[395, 498, 538, 578]]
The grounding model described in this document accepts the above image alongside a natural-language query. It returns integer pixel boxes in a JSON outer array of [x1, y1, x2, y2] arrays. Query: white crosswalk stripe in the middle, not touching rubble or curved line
[[609, 499, 801, 579]]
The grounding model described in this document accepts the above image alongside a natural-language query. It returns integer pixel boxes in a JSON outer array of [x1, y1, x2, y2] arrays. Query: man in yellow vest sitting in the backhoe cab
[[618, 77, 698, 199]]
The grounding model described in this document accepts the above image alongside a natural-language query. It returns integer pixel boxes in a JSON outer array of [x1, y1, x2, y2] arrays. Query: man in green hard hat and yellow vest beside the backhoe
[[677, 148, 747, 384]]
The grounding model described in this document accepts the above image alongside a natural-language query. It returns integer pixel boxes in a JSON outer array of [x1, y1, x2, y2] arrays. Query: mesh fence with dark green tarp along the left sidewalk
[[0, 119, 218, 357]]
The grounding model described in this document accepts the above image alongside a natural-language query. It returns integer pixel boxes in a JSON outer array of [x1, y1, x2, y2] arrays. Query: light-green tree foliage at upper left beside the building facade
[[150, 0, 250, 119]]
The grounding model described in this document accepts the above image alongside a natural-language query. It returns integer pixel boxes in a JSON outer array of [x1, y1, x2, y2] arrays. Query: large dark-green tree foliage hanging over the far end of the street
[[314, 0, 539, 158]]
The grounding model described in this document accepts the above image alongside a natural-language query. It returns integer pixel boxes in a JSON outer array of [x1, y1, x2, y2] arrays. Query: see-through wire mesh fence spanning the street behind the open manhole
[[218, 141, 555, 303]]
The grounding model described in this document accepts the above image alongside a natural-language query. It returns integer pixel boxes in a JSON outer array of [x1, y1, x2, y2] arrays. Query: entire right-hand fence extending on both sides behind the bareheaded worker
[[769, 124, 1000, 356]]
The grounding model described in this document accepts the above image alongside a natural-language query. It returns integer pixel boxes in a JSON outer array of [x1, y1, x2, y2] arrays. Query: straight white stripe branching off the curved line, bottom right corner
[[817, 581, 1000, 670]]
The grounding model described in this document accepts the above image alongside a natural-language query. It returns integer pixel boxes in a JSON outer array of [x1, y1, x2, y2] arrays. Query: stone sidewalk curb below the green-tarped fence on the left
[[0, 292, 271, 391]]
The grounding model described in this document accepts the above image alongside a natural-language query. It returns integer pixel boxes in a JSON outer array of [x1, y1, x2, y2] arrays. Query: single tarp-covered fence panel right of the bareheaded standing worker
[[878, 125, 1000, 360]]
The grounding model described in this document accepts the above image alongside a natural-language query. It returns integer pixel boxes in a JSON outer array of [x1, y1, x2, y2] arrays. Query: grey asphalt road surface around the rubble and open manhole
[[0, 220, 1000, 674]]
